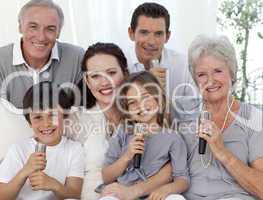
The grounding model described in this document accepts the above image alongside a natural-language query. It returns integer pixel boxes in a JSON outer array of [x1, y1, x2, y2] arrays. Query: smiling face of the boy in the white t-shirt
[[29, 109, 64, 146]]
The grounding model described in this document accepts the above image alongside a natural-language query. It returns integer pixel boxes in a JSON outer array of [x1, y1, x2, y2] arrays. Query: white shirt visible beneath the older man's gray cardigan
[[13, 40, 59, 84]]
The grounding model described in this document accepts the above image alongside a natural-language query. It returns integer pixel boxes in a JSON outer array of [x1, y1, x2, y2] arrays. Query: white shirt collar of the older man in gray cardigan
[[13, 39, 60, 66]]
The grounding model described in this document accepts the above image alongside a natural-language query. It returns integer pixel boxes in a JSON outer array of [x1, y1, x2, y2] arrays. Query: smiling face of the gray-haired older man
[[19, 7, 60, 68]]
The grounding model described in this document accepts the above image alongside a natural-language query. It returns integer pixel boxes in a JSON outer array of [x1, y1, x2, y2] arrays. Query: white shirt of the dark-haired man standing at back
[[126, 47, 193, 98]]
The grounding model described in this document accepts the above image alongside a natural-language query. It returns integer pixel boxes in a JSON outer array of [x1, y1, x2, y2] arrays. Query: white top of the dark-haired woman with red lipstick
[[66, 105, 109, 200]]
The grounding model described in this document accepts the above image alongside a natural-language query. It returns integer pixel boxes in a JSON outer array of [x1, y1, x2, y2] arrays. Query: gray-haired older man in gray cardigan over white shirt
[[0, 0, 84, 108]]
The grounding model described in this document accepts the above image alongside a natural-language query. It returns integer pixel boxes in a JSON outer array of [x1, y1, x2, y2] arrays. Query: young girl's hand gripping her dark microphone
[[124, 135, 144, 161]]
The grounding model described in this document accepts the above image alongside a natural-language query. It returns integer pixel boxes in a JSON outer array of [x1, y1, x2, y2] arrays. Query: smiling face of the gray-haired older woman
[[194, 56, 232, 102]]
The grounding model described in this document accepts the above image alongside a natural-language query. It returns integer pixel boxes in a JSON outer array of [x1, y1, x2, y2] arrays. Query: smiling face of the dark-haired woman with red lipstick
[[86, 54, 124, 106]]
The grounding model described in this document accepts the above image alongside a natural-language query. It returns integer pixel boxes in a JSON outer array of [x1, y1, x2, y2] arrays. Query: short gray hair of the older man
[[18, 0, 64, 31]]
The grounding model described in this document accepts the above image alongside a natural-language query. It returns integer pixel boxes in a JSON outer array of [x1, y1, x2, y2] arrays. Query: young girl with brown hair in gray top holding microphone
[[102, 71, 189, 200]]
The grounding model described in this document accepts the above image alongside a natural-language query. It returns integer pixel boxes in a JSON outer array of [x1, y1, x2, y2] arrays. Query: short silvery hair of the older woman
[[188, 35, 238, 84]]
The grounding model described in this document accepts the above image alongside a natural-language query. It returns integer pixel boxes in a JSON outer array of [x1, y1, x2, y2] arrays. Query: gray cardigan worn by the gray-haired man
[[0, 42, 84, 108]]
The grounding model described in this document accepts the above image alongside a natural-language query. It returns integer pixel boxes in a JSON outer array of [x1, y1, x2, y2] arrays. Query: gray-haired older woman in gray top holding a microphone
[[183, 36, 263, 200]]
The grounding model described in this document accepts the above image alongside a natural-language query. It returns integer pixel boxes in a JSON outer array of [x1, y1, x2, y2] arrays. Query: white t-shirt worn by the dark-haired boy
[[0, 137, 84, 200]]
